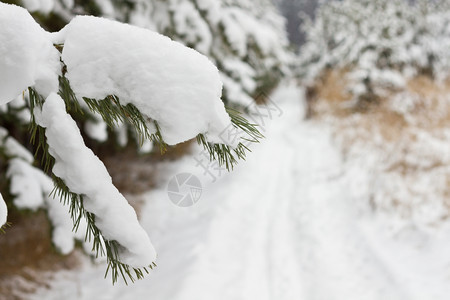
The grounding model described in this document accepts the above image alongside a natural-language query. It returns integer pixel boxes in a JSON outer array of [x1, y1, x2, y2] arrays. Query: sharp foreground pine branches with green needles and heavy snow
[[0, 1, 261, 282]]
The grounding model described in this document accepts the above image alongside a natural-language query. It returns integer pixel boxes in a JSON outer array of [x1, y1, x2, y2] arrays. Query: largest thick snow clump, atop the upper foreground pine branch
[[62, 16, 231, 144]]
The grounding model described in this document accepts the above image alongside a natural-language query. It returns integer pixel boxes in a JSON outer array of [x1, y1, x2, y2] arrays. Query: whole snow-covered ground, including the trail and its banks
[[30, 82, 450, 300]]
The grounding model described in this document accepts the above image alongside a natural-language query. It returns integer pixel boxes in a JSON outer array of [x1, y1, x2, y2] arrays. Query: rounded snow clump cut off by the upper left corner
[[0, 3, 60, 105]]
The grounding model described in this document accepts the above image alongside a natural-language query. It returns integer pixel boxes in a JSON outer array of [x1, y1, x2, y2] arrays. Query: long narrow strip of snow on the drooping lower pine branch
[[34, 93, 156, 267]]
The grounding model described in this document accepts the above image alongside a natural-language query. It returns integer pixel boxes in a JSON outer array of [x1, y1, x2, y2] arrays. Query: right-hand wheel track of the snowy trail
[[291, 126, 407, 299]]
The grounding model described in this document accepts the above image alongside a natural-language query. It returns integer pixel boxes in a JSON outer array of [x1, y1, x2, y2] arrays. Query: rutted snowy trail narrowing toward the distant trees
[[169, 83, 405, 299]]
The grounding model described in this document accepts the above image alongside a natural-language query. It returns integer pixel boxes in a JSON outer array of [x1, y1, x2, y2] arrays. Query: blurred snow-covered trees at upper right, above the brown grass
[[298, 0, 450, 103]]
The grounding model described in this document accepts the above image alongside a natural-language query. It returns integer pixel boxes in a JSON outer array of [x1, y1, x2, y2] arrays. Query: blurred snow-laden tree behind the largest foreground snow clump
[[14, 0, 291, 106]]
